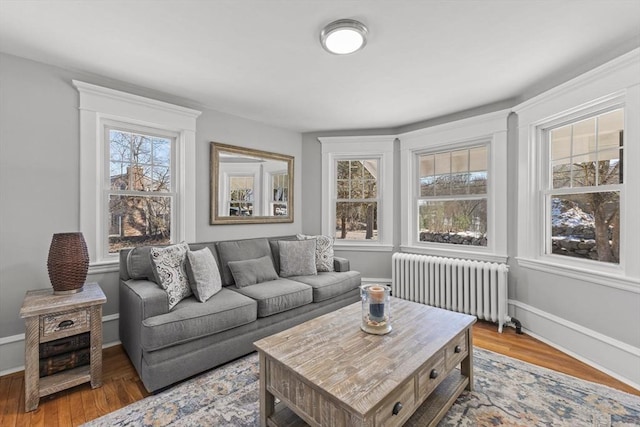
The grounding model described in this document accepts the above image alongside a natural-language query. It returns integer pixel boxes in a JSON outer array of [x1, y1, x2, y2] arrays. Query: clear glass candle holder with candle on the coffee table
[[360, 285, 391, 335]]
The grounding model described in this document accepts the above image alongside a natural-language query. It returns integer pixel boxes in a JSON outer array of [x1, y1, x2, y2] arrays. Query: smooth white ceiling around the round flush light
[[0, 0, 640, 132]]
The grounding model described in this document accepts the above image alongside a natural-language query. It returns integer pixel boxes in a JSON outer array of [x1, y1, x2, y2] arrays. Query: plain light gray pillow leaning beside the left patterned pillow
[[187, 248, 222, 302]]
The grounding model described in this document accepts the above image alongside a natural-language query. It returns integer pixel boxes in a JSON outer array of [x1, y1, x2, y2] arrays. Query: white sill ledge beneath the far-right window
[[516, 257, 640, 293]]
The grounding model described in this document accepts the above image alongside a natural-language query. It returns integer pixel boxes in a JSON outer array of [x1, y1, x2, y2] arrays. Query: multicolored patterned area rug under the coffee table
[[85, 348, 640, 427]]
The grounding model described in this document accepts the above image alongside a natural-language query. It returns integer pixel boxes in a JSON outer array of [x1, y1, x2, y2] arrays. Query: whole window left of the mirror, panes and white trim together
[[73, 80, 200, 273]]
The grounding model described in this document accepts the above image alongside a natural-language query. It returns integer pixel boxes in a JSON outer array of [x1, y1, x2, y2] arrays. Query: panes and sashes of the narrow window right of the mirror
[[335, 159, 379, 240]]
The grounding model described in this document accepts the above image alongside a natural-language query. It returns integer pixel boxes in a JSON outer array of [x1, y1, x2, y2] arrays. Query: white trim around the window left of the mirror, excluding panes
[[72, 80, 201, 271]]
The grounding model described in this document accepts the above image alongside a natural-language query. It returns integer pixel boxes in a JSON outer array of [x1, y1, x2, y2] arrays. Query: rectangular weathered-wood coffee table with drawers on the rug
[[254, 298, 476, 427]]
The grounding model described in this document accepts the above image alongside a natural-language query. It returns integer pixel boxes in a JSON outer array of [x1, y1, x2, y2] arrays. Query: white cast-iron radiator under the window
[[391, 253, 511, 333]]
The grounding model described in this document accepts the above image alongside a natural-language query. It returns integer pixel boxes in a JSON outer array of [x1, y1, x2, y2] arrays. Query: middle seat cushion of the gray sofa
[[232, 279, 313, 317]]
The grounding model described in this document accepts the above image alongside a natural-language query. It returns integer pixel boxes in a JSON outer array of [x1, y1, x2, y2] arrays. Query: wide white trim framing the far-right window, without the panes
[[514, 49, 640, 288]]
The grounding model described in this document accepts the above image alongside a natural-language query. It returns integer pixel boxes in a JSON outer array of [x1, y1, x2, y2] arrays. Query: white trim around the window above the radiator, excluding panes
[[398, 110, 510, 262]]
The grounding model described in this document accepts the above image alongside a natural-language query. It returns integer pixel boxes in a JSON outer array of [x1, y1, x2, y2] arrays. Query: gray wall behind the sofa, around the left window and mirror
[[0, 54, 302, 372]]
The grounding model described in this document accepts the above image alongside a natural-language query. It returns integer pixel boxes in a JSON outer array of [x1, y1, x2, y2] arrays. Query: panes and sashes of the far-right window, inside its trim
[[544, 108, 624, 264]]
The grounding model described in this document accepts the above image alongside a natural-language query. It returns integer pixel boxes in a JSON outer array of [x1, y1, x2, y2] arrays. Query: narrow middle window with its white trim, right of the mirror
[[318, 136, 396, 252]]
